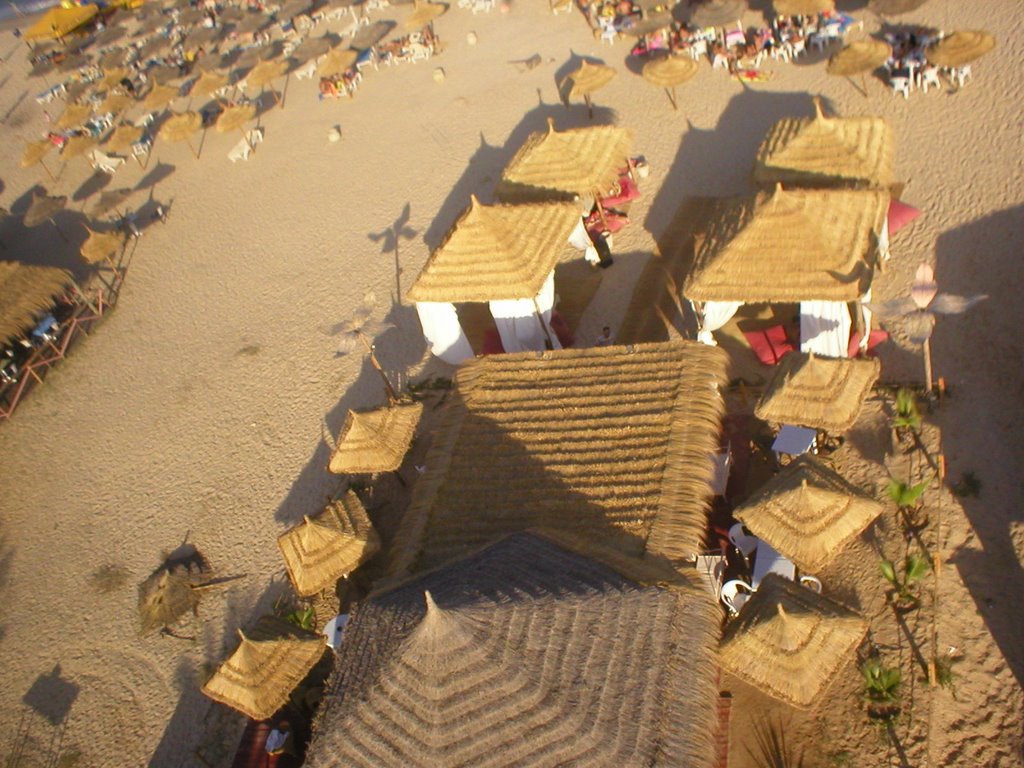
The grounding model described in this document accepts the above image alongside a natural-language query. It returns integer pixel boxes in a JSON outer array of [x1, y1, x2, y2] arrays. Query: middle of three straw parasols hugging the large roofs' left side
[[278, 490, 381, 597]]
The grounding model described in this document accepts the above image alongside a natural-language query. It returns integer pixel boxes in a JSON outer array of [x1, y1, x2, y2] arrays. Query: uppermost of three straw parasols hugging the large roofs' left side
[[328, 402, 423, 474]]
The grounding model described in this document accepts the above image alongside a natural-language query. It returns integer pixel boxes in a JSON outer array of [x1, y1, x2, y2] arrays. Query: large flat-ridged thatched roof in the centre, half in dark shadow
[[390, 342, 724, 575]]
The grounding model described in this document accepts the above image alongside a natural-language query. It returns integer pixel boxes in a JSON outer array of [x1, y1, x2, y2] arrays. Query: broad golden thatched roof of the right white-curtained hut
[[683, 187, 889, 303]]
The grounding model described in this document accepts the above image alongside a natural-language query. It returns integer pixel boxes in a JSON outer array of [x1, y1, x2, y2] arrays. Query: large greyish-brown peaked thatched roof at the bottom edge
[[306, 534, 720, 768]]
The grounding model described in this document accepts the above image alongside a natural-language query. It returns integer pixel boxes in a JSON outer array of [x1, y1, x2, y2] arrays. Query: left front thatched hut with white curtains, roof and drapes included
[[409, 197, 583, 365]]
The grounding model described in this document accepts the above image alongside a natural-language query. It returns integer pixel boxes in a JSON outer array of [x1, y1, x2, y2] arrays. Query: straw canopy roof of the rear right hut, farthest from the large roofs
[[754, 100, 895, 188]]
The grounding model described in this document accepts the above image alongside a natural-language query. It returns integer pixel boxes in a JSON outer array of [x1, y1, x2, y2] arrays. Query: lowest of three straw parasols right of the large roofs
[[719, 573, 867, 707]]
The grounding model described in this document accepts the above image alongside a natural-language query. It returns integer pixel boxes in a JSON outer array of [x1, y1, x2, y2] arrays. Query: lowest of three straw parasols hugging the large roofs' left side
[[203, 616, 327, 720]]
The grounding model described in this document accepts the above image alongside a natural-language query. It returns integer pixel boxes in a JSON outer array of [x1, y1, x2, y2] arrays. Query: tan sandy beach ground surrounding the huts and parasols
[[0, 0, 1024, 768]]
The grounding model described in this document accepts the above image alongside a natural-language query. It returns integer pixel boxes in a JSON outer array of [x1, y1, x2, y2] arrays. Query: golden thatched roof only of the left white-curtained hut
[[409, 197, 580, 302]]
